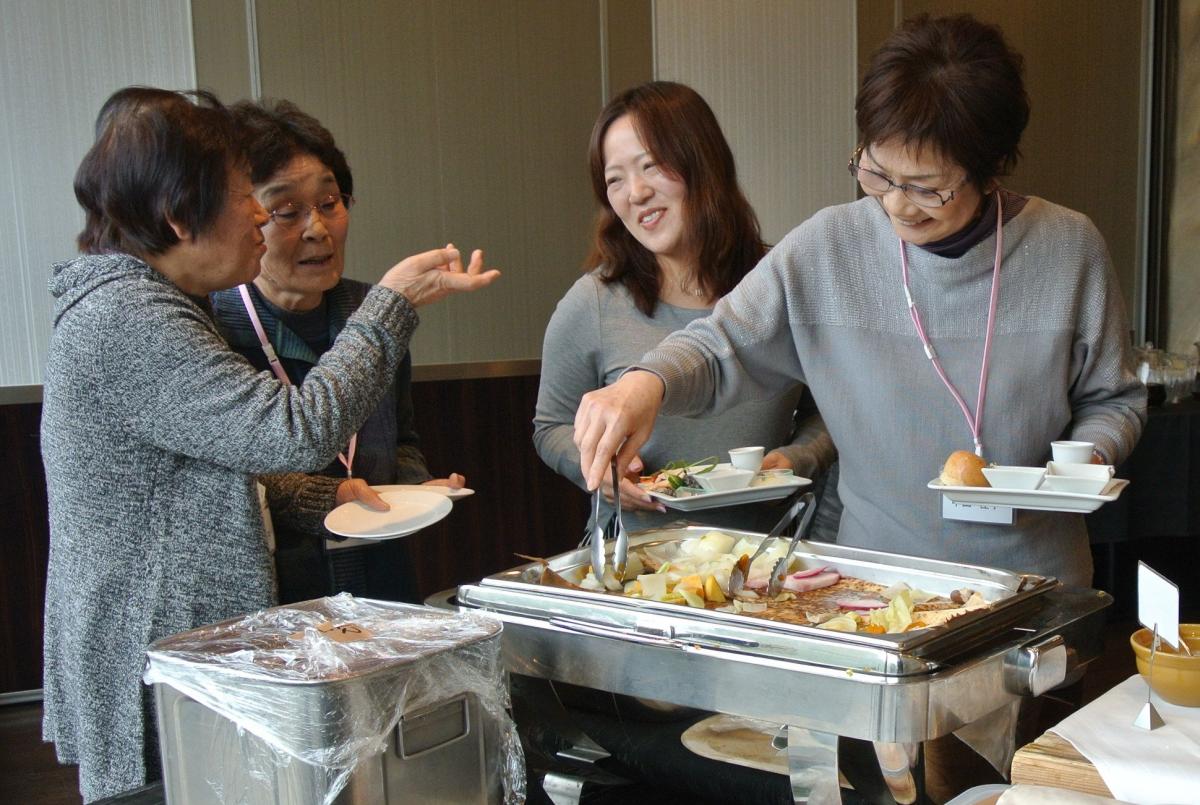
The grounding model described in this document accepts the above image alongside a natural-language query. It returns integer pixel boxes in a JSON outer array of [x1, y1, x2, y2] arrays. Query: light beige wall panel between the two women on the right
[[654, 0, 856, 242]]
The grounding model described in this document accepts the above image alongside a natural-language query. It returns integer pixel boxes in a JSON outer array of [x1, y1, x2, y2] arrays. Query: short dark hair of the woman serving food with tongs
[[854, 14, 1030, 190]]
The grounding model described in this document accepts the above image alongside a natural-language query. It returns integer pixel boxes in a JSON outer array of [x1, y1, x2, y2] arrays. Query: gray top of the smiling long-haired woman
[[533, 271, 834, 530]]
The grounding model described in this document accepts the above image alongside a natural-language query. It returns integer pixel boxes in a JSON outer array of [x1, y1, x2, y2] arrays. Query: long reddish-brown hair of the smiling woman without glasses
[[587, 82, 767, 316]]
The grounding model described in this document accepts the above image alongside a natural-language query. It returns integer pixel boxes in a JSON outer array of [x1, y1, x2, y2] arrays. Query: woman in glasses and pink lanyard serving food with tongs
[[575, 16, 1145, 585]]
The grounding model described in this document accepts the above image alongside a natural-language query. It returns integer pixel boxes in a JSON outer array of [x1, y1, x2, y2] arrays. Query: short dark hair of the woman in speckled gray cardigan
[[74, 86, 242, 256]]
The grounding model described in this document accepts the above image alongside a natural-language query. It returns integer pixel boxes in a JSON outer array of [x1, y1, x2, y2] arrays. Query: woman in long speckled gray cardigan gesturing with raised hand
[[42, 86, 497, 801]]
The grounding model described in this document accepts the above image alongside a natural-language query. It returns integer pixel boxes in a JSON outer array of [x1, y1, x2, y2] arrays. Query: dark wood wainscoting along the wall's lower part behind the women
[[0, 376, 587, 693]]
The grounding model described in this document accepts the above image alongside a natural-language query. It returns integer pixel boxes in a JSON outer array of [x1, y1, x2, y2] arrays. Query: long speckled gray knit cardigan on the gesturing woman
[[42, 254, 416, 801]]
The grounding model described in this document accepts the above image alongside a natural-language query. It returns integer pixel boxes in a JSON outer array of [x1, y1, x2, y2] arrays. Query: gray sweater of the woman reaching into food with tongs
[[641, 198, 1146, 585]]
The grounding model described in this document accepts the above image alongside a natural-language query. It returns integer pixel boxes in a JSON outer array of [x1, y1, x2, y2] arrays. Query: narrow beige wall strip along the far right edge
[[1164, 2, 1200, 353]]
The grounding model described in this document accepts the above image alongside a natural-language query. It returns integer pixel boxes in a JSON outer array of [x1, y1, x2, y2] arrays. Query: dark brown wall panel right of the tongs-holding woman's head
[[859, 0, 1142, 326]]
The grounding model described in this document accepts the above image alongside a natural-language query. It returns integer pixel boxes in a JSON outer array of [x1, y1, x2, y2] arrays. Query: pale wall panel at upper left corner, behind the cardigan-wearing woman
[[0, 0, 194, 386]]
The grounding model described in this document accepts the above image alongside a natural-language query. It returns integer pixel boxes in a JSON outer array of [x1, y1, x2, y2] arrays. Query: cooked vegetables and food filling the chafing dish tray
[[578, 531, 989, 633]]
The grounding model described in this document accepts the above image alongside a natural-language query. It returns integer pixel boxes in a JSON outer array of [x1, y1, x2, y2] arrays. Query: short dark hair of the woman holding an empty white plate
[[232, 100, 354, 193]]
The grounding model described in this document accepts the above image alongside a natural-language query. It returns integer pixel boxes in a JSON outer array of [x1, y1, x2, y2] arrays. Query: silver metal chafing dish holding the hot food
[[451, 527, 1111, 803]]
